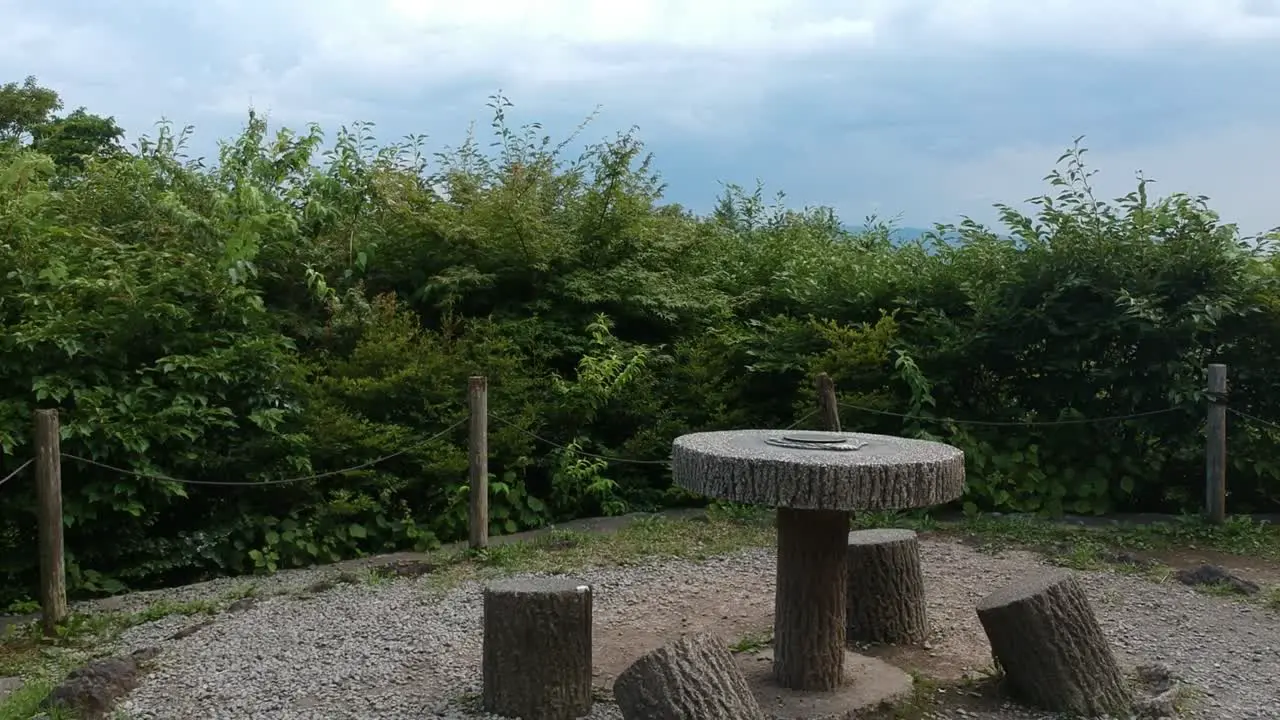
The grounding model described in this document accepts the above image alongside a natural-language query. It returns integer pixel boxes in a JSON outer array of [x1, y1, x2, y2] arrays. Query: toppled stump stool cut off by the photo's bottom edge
[[613, 633, 764, 720]]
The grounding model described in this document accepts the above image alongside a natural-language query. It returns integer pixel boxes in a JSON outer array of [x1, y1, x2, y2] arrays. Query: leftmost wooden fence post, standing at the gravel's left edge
[[36, 410, 68, 635]]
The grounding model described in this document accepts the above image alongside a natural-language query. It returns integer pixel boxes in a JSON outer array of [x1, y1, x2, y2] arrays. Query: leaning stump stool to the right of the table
[[977, 571, 1133, 717]]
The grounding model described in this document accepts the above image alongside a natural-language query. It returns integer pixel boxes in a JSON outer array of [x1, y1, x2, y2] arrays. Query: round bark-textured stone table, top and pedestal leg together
[[671, 430, 964, 691]]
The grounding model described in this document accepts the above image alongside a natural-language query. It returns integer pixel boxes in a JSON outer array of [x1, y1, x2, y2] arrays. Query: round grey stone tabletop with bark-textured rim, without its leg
[[671, 430, 964, 511]]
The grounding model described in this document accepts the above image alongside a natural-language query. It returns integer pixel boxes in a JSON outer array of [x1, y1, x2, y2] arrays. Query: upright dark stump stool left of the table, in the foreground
[[481, 578, 591, 720]]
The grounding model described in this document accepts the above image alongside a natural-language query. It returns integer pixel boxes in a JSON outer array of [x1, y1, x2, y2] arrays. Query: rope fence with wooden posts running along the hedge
[[0, 365, 1280, 633]]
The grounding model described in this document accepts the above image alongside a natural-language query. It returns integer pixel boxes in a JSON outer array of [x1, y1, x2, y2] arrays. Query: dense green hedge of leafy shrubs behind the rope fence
[[0, 79, 1280, 603]]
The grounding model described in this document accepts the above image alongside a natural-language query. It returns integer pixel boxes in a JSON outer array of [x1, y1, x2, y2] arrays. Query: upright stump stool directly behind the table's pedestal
[[845, 529, 929, 644]]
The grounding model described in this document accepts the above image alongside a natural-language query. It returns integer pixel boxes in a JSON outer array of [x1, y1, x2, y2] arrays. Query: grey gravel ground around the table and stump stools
[[107, 541, 1280, 720]]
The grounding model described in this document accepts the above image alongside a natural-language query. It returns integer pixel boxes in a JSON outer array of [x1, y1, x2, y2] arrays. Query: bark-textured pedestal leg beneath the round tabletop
[[773, 507, 849, 691]]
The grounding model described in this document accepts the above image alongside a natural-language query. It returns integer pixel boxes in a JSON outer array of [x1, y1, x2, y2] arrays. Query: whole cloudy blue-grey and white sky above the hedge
[[0, 0, 1280, 232]]
